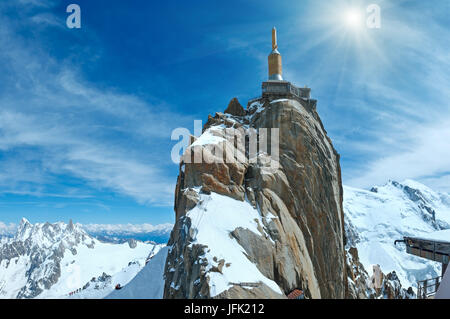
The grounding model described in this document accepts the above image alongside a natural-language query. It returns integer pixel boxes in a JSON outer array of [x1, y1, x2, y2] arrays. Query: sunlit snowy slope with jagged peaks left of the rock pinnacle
[[0, 219, 161, 298]]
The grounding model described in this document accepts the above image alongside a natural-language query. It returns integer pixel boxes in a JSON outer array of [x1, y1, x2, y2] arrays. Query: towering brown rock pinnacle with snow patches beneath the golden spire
[[164, 99, 348, 298]]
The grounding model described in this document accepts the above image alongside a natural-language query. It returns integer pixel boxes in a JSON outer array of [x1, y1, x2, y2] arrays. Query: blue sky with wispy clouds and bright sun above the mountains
[[0, 0, 450, 224]]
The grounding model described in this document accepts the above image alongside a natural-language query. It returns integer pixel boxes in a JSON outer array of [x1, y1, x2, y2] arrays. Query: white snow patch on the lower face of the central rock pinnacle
[[168, 189, 283, 297]]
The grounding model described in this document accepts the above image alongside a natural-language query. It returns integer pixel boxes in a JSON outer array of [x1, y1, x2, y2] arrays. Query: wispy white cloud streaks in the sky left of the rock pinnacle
[[0, 0, 186, 205]]
